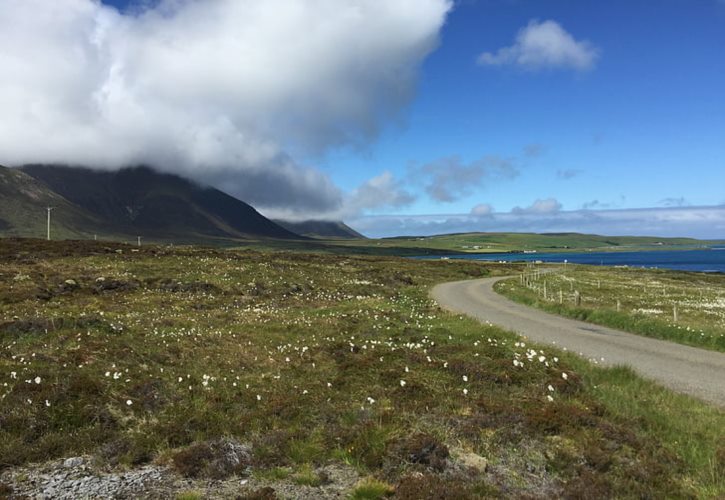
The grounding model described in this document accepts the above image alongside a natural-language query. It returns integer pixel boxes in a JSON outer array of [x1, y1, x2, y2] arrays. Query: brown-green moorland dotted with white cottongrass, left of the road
[[0, 240, 725, 498]]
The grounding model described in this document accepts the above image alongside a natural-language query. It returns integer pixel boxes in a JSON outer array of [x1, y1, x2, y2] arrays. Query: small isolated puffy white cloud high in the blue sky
[[478, 20, 599, 70]]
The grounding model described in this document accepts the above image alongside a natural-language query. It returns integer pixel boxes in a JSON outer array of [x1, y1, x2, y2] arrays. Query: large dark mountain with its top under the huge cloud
[[0, 165, 300, 241]]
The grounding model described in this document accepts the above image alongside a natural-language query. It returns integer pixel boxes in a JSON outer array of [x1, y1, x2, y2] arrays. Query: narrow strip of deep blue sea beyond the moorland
[[416, 248, 725, 273]]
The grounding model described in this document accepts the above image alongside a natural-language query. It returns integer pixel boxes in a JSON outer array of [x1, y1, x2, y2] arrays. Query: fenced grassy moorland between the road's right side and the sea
[[496, 265, 725, 352]]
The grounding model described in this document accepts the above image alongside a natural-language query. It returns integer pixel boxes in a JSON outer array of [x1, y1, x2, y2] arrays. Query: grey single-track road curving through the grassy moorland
[[431, 277, 725, 407]]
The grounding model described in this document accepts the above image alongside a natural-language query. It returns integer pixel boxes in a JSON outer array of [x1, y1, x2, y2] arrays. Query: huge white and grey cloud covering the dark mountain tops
[[0, 0, 452, 214]]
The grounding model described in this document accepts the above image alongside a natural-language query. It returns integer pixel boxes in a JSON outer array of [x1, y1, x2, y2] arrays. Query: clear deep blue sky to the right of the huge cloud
[[324, 0, 725, 213]]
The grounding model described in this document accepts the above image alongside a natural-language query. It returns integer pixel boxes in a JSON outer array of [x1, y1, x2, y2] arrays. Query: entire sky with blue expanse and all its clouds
[[0, 0, 725, 238]]
